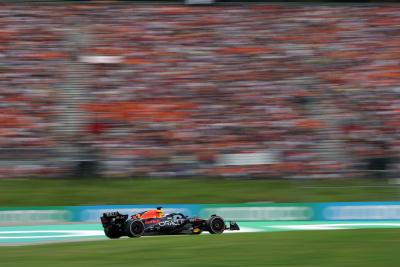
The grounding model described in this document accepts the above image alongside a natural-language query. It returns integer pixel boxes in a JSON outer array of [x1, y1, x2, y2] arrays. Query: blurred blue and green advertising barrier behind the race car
[[0, 202, 400, 225]]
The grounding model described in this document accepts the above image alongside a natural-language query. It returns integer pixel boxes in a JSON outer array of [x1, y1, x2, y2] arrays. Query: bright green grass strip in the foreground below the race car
[[0, 229, 400, 267]]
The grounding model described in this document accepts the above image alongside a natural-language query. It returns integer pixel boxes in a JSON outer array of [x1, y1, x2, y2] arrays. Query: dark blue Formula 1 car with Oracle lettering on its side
[[100, 212, 240, 239]]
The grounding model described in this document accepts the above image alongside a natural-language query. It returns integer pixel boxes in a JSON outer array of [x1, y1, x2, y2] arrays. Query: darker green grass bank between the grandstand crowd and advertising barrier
[[0, 179, 400, 207]]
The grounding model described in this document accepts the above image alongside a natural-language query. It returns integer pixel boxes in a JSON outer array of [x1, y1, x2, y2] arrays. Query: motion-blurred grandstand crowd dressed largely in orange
[[0, 3, 400, 178]]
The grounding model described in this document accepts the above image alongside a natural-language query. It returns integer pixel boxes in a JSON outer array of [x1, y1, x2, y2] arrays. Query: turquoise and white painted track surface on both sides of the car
[[0, 221, 400, 246]]
